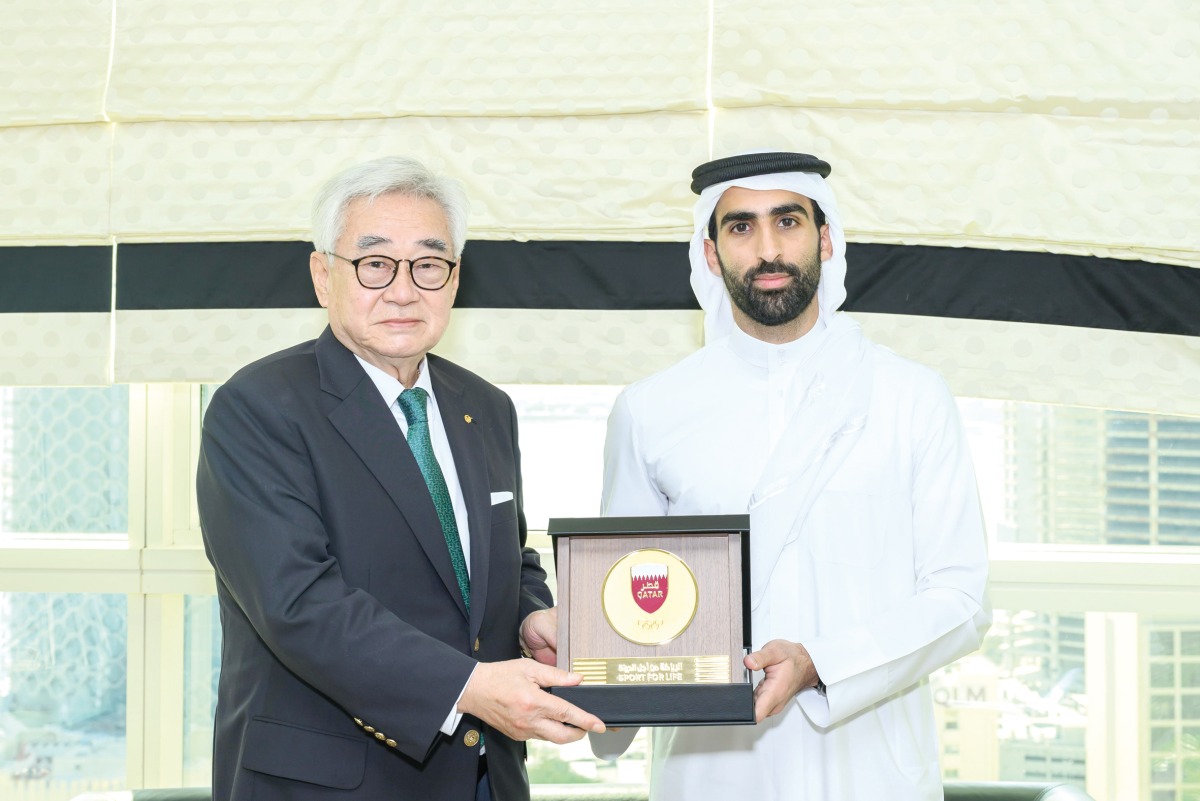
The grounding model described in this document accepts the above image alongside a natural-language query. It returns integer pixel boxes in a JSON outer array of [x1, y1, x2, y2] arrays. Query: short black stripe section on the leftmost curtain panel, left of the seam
[[0, 245, 113, 314]]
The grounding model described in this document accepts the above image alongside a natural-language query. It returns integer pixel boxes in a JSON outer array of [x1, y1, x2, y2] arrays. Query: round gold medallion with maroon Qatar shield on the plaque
[[600, 548, 700, 645]]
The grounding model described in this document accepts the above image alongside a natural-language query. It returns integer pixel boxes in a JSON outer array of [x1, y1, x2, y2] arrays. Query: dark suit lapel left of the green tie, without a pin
[[317, 329, 465, 618]]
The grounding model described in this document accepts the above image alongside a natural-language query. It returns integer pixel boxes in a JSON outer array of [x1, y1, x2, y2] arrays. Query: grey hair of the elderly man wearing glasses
[[312, 156, 470, 259]]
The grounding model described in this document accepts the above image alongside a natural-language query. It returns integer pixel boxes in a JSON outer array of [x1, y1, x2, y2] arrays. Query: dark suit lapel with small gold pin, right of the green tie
[[428, 355, 492, 638]]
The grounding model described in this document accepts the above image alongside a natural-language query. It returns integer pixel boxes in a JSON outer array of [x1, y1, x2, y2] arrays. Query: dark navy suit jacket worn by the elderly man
[[197, 329, 551, 801]]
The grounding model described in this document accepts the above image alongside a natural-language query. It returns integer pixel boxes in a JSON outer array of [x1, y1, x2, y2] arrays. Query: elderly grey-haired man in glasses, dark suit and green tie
[[197, 151, 604, 801]]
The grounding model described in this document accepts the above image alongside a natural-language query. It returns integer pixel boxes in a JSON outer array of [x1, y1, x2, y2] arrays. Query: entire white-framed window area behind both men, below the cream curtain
[[0, 385, 1200, 801]]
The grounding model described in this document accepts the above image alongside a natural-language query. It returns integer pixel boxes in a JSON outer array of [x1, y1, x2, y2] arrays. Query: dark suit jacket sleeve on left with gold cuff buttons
[[197, 385, 475, 760]]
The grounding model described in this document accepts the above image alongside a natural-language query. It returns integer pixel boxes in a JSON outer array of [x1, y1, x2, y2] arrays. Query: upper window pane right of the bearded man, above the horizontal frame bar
[[984, 399, 1200, 548]]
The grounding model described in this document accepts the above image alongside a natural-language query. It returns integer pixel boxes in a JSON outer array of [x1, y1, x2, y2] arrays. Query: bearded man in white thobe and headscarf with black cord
[[593, 152, 991, 801]]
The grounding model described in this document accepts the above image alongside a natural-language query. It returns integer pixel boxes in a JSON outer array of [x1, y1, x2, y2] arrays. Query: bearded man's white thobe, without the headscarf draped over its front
[[602, 316, 990, 801]]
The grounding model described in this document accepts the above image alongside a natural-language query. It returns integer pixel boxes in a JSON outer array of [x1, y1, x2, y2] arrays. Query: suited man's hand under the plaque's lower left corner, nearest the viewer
[[458, 660, 604, 745]]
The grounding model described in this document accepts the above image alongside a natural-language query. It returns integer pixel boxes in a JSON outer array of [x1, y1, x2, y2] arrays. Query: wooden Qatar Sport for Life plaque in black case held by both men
[[548, 514, 754, 725]]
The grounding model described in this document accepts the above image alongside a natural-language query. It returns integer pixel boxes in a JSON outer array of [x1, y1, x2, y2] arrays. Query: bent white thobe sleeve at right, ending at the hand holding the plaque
[[797, 380, 991, 727]]
